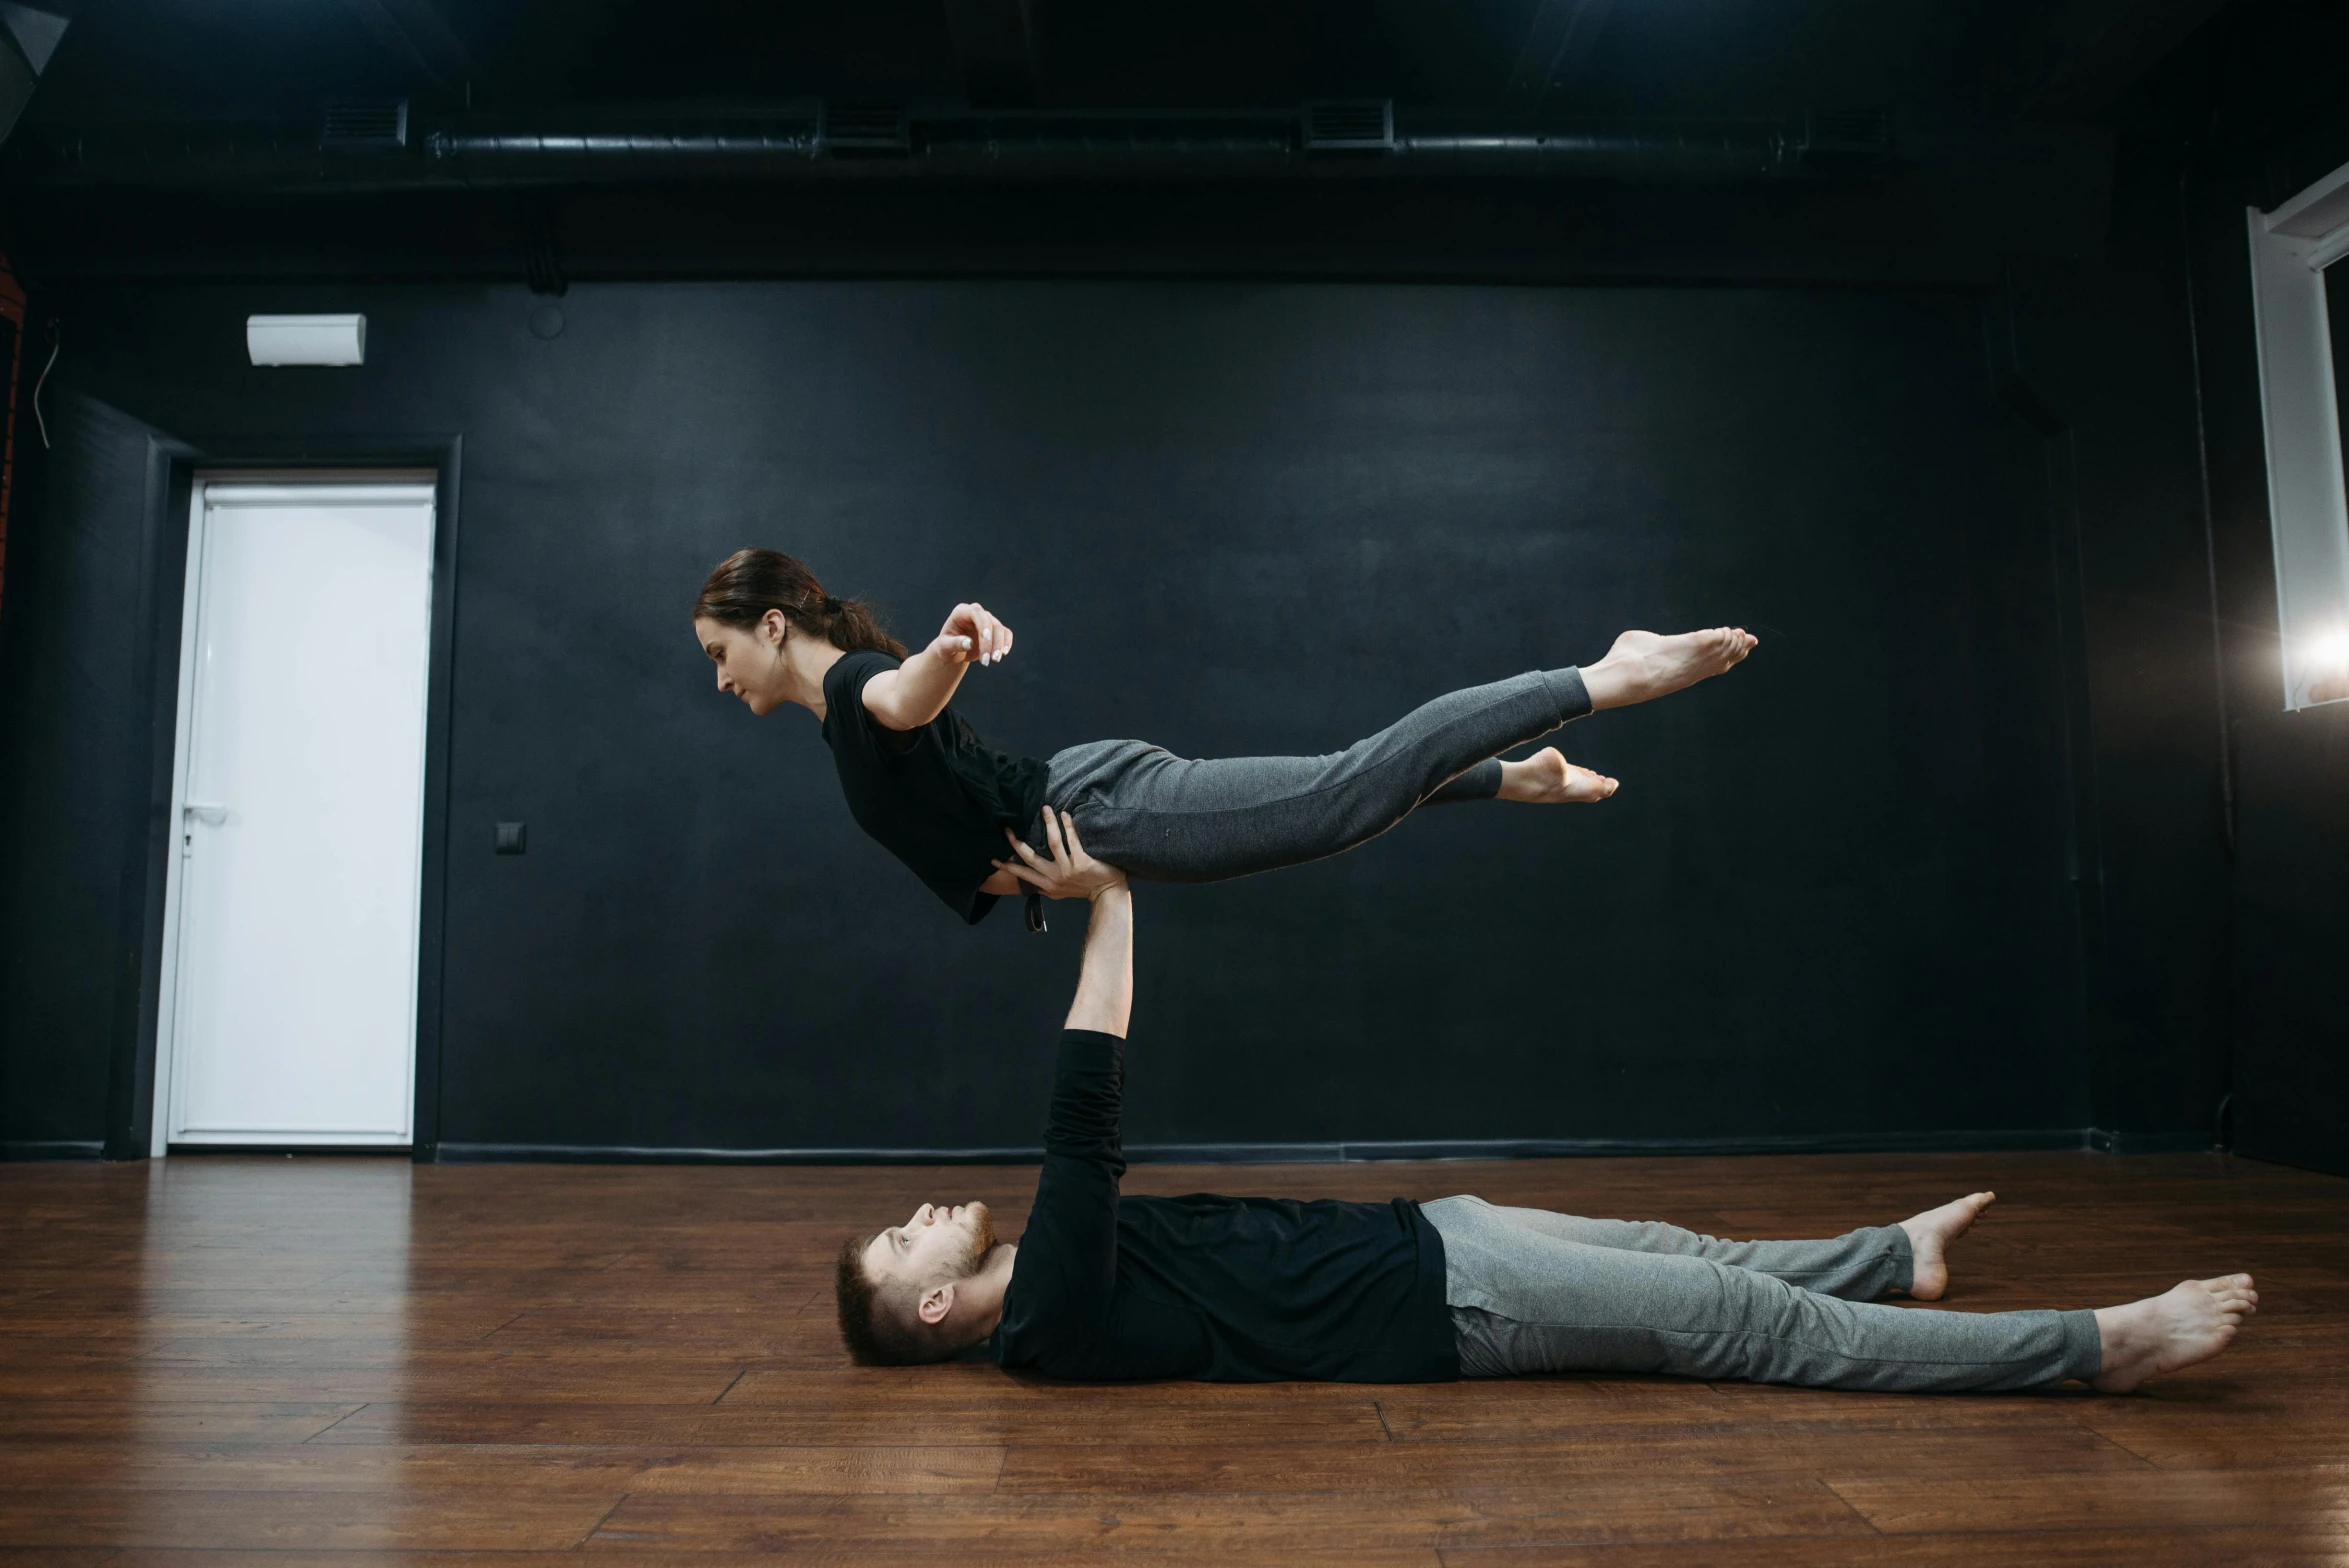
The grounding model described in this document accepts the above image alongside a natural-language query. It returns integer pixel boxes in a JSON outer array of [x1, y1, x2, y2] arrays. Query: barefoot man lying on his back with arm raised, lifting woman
[[839, 812, 2260, 1392]]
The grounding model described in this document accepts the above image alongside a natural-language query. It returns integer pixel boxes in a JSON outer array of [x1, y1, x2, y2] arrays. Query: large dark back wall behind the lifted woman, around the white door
[[0, 282, 2123, 1148]]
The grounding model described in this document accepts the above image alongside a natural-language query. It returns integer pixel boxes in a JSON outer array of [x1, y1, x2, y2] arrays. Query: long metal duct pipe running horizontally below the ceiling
[[5, 110, 1882, 192]]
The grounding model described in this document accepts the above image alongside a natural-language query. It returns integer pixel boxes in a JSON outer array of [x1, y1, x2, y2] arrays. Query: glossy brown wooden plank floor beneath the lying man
[[0, 1155, 2349, 1568]]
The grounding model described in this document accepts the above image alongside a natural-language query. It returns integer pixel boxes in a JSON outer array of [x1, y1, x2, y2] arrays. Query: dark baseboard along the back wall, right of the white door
[[418, 1127, 2210, 1164]]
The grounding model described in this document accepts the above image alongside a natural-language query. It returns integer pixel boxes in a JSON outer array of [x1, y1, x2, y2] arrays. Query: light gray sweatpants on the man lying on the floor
[[1419, 1197, 2102, 1394]]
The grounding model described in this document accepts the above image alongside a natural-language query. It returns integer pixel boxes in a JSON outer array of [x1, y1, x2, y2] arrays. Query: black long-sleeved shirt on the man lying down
[[994, 1030, 1459, 1383]]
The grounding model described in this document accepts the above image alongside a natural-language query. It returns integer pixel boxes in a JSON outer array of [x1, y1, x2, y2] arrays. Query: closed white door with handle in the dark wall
[[157, 479, 432, 1145]]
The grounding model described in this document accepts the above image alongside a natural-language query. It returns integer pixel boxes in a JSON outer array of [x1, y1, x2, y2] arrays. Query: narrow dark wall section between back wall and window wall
[[2011, 251, 2229, 1148]]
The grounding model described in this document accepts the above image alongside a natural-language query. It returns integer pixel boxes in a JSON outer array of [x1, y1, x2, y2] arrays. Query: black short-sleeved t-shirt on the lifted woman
[[824, 650, 1045, 925]]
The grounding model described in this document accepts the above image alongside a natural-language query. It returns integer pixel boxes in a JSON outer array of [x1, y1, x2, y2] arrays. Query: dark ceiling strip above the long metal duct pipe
[[28, 0, 2215, 127]]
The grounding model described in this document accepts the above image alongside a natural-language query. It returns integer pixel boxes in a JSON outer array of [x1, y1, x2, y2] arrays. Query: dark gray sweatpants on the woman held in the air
[[1029, 669, 1590, 883]]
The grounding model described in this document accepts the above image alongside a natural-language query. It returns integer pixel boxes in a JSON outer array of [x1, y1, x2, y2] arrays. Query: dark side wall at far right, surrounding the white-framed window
[[2126, 0, 2349, 1174]]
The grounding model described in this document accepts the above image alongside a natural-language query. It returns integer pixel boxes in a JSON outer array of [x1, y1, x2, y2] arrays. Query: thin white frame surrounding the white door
[[148, 467, 442, 1160]]
